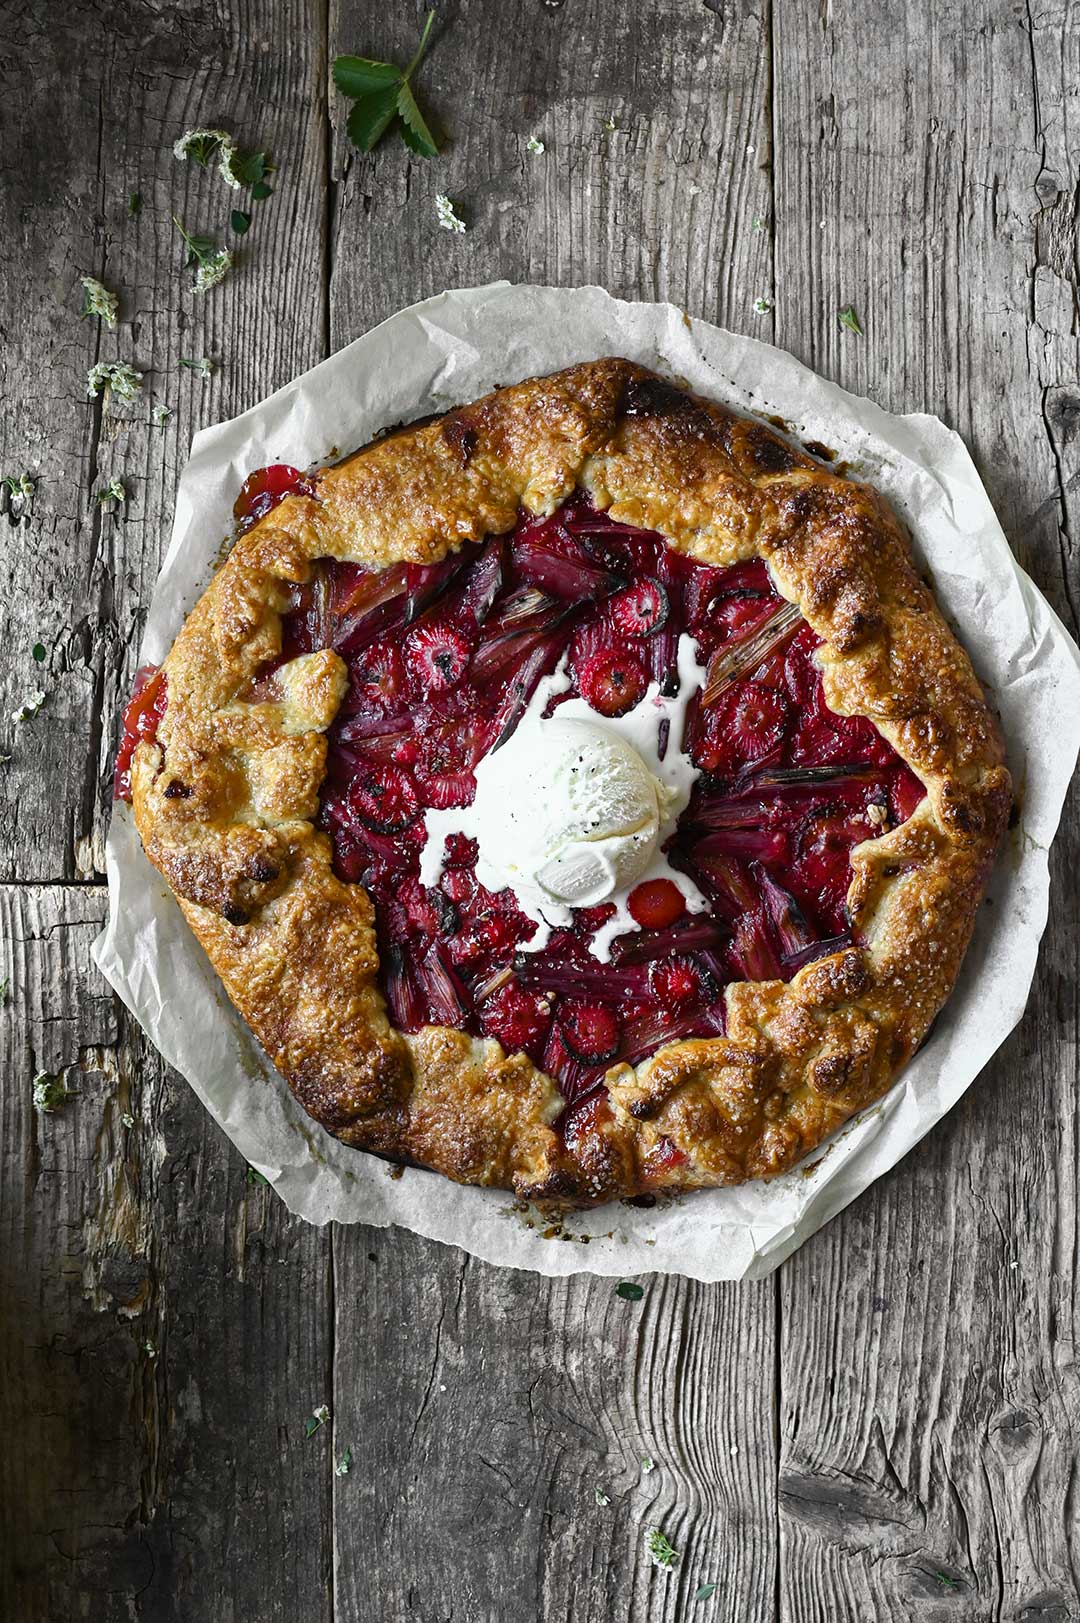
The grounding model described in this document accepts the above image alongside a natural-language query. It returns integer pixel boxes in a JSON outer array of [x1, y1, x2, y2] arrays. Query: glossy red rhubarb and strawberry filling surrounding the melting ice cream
[[222, 486, 922, 1123]]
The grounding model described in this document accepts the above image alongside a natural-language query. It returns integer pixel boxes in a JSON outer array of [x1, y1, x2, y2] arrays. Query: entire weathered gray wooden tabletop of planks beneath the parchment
[[0, 0, 1080, 1623]]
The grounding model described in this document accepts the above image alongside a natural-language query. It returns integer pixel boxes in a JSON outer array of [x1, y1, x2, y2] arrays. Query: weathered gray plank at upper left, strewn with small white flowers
[[0, 0, 325, 880]]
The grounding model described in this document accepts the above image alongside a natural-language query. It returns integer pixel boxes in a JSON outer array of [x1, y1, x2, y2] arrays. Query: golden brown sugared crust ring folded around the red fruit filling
[[132, 360, 1010, 1204]]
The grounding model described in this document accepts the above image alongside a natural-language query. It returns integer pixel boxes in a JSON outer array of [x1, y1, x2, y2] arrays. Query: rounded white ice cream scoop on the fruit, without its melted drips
[[473, 716, 671, 907]]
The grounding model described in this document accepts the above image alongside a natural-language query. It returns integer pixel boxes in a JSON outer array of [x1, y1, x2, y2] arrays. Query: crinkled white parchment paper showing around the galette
[[94, 282, 1080, 1279]]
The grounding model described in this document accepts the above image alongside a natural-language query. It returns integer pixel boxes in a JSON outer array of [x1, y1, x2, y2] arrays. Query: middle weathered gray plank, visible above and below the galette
[[324, 0, 776, 1623]]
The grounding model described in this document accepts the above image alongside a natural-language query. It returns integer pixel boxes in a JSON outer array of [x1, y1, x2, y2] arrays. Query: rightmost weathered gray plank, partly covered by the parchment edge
[[775, 0, 1080, 1623]]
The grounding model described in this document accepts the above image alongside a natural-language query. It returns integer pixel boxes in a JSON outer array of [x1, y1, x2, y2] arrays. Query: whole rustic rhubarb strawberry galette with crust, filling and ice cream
[[119, 360, 1010, 1204]]
